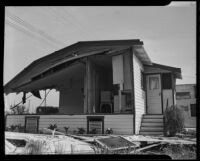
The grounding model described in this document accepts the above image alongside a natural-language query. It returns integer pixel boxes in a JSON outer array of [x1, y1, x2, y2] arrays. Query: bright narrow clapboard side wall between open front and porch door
[[133, 54, 146, 134]]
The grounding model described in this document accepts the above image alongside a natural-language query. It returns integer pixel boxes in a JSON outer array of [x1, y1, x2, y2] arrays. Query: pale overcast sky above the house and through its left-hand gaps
[[4, 2, 196, 110]]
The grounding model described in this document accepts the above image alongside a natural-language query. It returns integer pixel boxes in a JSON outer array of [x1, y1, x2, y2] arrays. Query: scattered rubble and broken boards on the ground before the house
[[5, 129, 196, 154]]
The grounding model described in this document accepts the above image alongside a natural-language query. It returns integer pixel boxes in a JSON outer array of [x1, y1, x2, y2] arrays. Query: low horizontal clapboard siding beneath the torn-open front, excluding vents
[[6, 114, 133, 134]]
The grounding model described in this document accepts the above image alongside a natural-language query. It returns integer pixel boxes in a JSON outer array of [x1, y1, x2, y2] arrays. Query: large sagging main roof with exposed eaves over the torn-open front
[[4, 39, 151, 94]]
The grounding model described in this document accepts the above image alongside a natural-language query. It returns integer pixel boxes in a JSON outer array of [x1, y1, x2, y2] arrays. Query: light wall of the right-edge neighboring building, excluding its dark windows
[[176, 84, 197, 128]]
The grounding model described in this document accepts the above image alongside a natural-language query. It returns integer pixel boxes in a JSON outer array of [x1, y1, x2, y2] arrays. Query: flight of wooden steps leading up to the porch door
[[139, 115, 164, 135]]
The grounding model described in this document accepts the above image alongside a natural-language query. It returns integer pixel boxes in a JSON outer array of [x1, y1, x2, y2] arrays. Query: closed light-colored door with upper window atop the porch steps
[[147, 74, 162, 114]]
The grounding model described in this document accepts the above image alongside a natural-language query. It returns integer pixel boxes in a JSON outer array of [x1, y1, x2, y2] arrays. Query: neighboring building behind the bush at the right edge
[[176, 84, 196, 128]]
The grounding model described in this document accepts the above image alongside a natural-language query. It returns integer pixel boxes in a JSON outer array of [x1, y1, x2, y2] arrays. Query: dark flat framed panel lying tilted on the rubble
[[95, 136, 137, 150]]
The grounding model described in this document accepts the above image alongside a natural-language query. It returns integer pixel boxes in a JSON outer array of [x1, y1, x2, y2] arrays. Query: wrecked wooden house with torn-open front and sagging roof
[[4, 39, 182, 135]]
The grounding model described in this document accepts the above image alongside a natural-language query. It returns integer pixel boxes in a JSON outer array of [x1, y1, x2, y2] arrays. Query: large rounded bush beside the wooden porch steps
[[164, 106, 184, 136]]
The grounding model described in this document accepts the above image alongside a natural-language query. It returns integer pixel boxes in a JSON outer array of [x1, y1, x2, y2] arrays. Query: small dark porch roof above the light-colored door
[[145, 63, 182, 79]]
